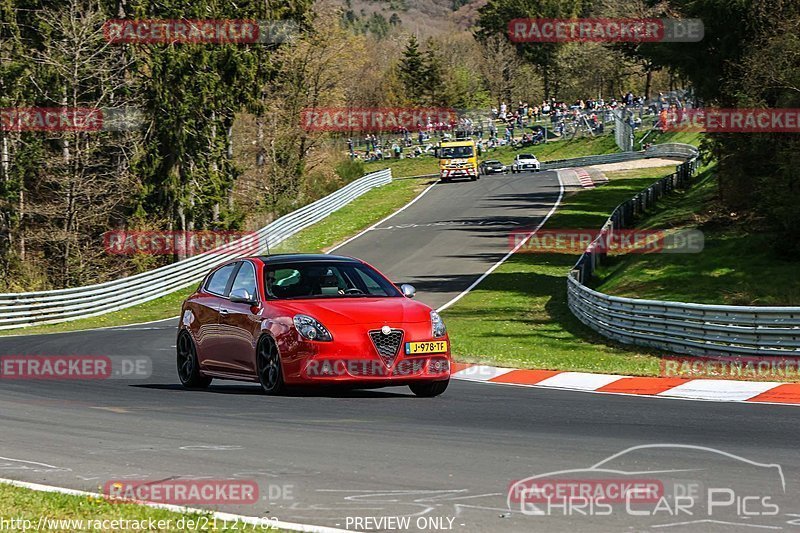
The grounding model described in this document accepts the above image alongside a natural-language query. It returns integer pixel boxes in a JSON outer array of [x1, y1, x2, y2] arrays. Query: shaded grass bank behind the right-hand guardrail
[[595, 163, 800, 306]]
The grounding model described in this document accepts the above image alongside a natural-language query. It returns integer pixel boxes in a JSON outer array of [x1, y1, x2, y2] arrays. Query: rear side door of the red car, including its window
[[197, 262, 239, 371]]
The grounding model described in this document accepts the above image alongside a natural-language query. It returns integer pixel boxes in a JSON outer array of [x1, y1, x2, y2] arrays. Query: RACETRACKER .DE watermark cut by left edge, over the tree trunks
[[0, 107, 144, 132]]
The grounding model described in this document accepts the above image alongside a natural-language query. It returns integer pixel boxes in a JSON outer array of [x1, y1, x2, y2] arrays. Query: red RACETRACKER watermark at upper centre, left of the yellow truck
[[300, 107, 459, 133]]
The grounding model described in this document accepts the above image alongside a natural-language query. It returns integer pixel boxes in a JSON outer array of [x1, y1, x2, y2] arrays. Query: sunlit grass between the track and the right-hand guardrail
[[444, 167, 674, 375]]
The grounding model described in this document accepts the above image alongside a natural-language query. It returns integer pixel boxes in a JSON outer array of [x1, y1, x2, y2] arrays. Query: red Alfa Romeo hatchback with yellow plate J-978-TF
[[177, 254, 450, 396]]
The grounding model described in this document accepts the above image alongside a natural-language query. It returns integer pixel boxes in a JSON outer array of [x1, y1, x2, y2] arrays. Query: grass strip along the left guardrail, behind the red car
[[0, 180, 427, 336]]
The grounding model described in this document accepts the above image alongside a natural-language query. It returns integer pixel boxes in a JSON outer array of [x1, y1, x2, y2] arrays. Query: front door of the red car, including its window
[[219, 260, 261, 375]]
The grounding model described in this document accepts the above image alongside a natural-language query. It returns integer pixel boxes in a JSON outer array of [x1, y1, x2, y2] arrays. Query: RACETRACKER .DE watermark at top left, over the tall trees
[[103, 19, 298, 44]]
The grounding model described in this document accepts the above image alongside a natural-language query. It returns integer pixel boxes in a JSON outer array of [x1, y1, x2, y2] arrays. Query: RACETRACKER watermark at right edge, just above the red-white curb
[[659, 357, 800, 381]]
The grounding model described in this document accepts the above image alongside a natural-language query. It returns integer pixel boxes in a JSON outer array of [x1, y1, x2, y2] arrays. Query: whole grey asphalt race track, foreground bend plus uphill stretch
[[0, 173, 800, 532]]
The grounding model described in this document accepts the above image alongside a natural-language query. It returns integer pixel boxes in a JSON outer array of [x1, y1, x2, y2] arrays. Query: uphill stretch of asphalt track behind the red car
[[335, 171, 561, 309]]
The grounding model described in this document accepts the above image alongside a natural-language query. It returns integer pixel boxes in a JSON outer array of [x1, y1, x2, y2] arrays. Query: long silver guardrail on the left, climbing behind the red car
[[0, 169, 392, 329]]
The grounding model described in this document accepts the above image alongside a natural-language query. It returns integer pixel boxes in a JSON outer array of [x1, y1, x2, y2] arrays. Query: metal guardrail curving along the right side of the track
[[567, 145, 800, 356]]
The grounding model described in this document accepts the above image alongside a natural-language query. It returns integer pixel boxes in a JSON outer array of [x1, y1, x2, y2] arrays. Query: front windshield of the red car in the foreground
[[264, 261, 402, 300]]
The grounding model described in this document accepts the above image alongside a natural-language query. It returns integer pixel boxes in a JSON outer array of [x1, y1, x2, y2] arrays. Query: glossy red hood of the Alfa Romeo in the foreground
[[271, 297, 431, 326]]
